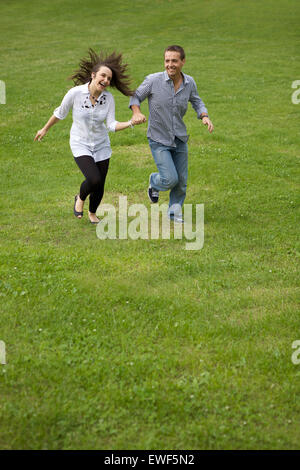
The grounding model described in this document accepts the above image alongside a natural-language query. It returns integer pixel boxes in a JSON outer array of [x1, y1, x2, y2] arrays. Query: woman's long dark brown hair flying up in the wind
[[69, 48, 134, 96]]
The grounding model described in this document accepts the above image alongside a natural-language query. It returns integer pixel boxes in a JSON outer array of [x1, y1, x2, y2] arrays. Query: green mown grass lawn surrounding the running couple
[[0, 0, 300, 450]]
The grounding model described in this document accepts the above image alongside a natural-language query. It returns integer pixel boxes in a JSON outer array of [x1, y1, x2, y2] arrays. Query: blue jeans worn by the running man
[[148, 137, 188, 215]]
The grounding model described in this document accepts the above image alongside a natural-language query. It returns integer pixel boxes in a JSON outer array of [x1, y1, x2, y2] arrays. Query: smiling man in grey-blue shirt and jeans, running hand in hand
[[129, 46, 213, 223]]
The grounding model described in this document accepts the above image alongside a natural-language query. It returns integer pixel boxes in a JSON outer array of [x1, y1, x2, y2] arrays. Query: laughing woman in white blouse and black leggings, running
[[34, 49, 141, 224]]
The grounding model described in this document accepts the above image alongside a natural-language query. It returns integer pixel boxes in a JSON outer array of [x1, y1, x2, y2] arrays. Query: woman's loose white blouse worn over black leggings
[[53, 83, 118, 162]]
